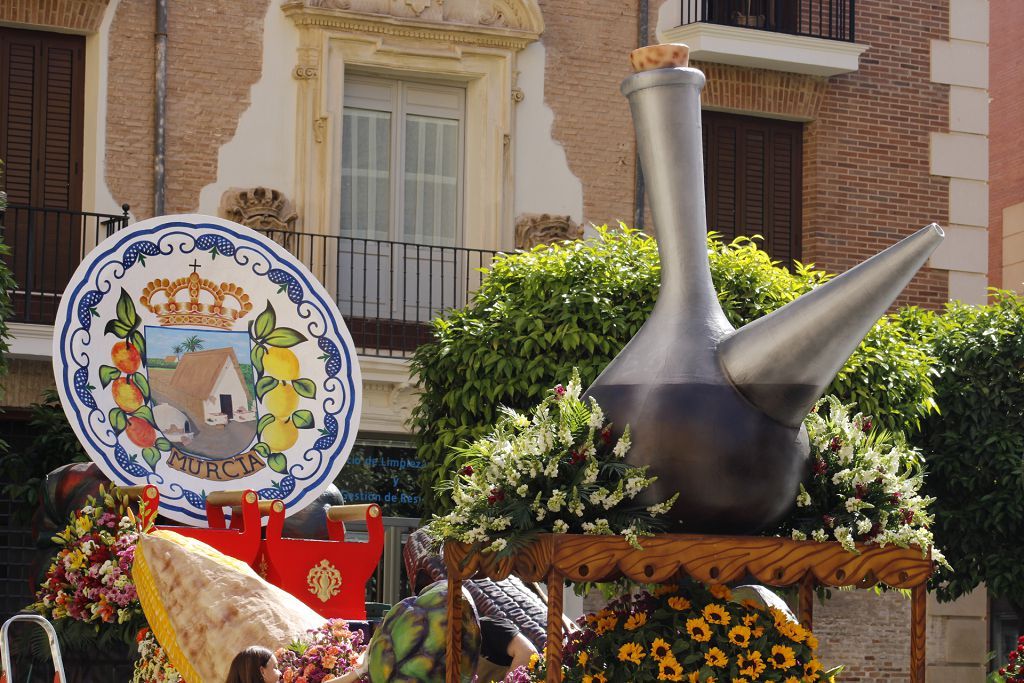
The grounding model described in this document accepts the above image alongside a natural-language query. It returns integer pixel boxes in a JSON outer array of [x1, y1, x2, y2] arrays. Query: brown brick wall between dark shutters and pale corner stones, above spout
[[804, 0, 949, 307]]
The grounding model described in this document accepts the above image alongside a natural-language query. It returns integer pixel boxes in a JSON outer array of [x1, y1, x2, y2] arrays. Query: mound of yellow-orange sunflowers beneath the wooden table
[[505, 581, 839, 683]]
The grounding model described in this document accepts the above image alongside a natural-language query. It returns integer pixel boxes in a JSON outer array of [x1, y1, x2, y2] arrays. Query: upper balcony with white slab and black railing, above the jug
[[664, 0, 867, 76]]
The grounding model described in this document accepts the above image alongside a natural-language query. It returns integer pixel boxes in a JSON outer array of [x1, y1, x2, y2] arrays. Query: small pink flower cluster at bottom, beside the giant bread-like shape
[[274, 620, 365, 683]]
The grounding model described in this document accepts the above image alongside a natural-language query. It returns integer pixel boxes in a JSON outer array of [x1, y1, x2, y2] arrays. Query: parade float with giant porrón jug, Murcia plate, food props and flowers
[[8, 41, 942, 683]]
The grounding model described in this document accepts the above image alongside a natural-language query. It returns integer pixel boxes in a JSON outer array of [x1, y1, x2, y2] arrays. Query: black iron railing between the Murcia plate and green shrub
[[254, 230, 497, 356]]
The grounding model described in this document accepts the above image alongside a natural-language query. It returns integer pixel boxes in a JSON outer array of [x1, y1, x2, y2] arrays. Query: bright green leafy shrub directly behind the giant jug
[[412, 226, 933, 513]]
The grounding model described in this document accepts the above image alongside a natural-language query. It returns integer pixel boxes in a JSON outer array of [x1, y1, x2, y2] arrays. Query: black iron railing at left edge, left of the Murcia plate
[[0, 204, 128, 325]]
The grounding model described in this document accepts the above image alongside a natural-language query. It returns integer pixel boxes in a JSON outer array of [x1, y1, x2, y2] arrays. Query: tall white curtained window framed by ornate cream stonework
[[338, 76, 466, 322]]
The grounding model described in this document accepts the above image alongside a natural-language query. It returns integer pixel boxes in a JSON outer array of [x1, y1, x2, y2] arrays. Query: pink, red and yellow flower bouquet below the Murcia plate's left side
[[30, 486, 145, 647]]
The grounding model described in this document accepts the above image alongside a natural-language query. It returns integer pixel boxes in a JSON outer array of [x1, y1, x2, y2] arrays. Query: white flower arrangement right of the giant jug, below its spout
[[781, 396, 945, 563]]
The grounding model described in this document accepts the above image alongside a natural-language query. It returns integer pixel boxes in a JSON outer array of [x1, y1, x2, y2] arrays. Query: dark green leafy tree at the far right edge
[[918, 292, 1024, 604]]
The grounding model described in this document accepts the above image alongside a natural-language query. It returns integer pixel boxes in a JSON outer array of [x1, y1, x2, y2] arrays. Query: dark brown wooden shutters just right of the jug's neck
[[701, 112, 803, 264]]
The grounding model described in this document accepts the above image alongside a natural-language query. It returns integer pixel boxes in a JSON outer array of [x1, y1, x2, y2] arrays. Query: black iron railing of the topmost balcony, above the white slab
[[680, 0, 855, 42]]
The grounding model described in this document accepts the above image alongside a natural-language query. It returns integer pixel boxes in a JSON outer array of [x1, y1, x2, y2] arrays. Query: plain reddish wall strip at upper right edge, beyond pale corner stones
[[988, 0, 1024, 291]]
